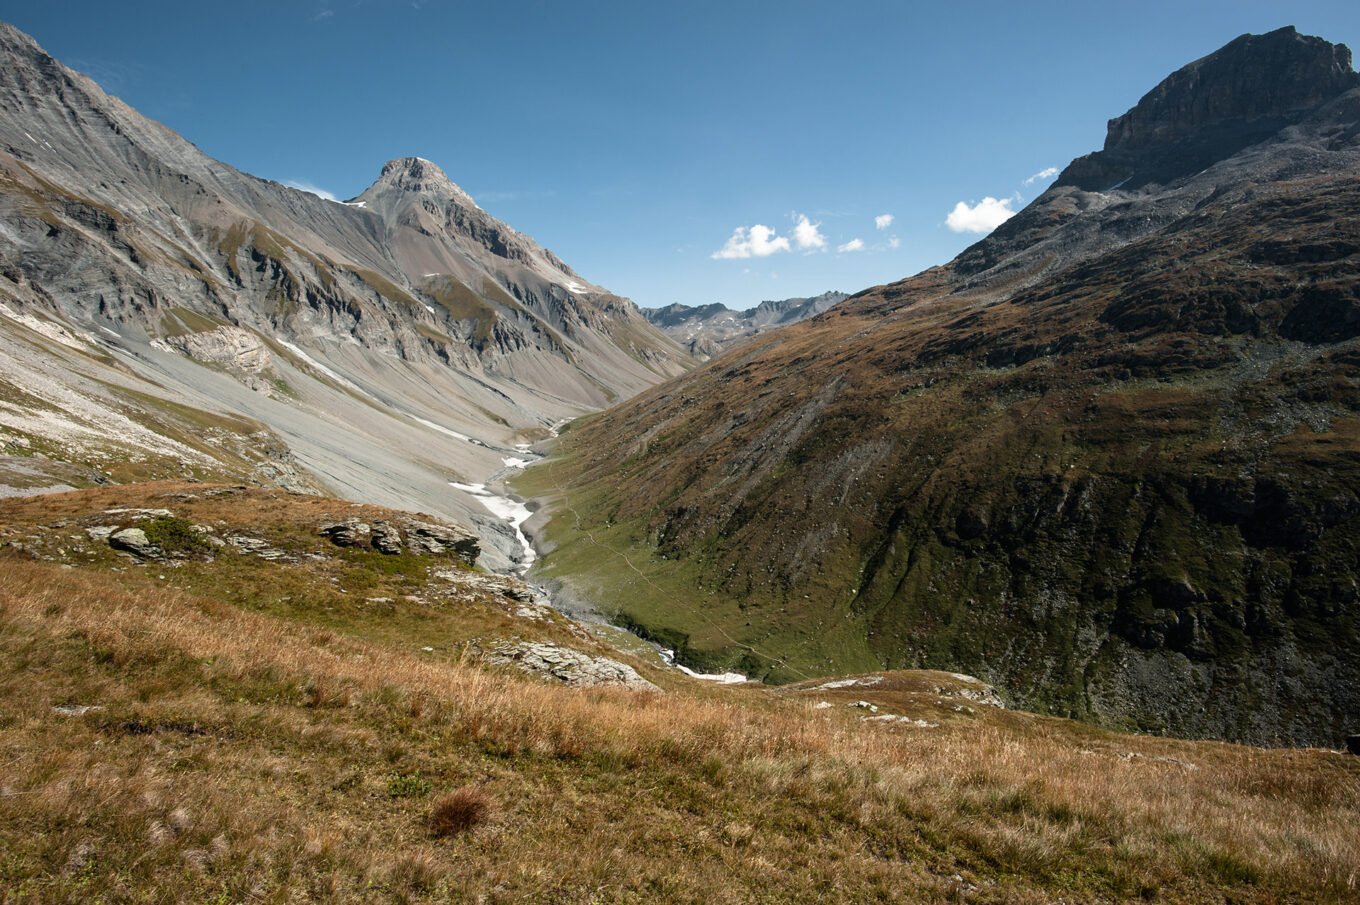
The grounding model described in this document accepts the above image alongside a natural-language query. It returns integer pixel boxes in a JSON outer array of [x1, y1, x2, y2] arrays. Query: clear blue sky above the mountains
[[0, 0, 1360, 308]]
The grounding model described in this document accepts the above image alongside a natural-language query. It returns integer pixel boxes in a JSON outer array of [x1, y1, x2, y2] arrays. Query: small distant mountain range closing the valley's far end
[[642, 291, 849, 361]]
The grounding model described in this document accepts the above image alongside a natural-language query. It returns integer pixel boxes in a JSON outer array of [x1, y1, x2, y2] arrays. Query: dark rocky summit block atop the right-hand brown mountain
[[1058, 26, 1360, 192]]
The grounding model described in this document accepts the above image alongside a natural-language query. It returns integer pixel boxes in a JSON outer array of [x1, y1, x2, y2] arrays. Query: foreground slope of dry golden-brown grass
[[0, 484, 1360, 902]]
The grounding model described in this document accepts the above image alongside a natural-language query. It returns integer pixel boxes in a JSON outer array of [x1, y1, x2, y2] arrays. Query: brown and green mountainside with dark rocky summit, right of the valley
[[525, 29, 1360, 744]]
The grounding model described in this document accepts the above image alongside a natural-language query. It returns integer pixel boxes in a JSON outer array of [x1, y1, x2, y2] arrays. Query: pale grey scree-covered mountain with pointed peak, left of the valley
[[0, 24, 692, 565]]
